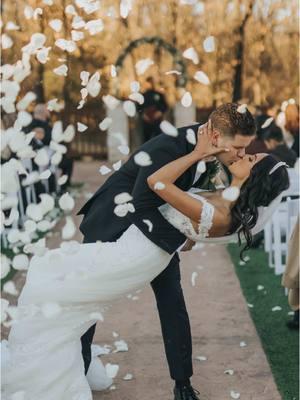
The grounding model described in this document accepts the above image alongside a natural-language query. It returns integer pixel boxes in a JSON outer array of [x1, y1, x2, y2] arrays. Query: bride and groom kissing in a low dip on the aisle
[[3, 103, 289, 400]]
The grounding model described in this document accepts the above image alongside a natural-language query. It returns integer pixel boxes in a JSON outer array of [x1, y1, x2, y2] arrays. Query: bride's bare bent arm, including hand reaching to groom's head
[[147, 126, 226, 223]]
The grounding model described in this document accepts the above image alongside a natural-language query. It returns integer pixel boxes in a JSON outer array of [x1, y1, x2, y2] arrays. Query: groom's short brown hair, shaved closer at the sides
[[209, 103, 256, 137]]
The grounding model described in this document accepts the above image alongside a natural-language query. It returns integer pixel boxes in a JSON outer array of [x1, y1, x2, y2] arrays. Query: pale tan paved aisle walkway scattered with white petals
[[3, 162, 281, 400]]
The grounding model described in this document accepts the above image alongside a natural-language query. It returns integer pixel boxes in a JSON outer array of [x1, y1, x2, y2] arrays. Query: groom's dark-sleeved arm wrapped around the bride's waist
[[127, 138, 186, 254]]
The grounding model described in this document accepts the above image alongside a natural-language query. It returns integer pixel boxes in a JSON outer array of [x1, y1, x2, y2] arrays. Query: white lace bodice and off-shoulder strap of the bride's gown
[[159, 192, 214, 242]]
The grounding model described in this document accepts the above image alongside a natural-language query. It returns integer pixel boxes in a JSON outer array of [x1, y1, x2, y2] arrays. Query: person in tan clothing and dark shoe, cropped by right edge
[[282, 217, 300, 329]]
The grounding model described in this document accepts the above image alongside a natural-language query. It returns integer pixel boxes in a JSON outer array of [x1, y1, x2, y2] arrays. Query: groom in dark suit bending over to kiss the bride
[[78, 103, 256, 400]]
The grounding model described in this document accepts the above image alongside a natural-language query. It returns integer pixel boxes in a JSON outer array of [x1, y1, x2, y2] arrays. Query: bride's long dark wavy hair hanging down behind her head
[[230, 155, 289, 259]]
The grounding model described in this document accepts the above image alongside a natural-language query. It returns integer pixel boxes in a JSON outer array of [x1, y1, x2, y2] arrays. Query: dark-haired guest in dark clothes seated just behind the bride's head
[[263, 123, 297, 167]]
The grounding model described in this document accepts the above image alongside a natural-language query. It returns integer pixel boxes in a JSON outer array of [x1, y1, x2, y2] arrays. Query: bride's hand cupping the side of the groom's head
[[193, 120, 229, 161]]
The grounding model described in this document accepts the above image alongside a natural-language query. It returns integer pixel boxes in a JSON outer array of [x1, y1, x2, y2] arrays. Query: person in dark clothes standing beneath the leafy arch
[[139, 77, 168, 143]]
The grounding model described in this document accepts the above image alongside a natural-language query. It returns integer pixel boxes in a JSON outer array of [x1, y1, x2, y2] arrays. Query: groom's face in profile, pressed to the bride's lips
[[217, 133, 255, 167]]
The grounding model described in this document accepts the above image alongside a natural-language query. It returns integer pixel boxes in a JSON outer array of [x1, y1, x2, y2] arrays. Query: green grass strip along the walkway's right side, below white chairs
[[228, 244, 299, 400]]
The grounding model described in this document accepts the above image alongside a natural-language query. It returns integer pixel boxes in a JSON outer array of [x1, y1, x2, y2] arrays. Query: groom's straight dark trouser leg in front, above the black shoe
[[151, 254, 193, 381]]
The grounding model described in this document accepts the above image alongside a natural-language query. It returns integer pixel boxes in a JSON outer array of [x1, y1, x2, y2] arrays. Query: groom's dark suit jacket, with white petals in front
[[78, 124, 204, 254]]
